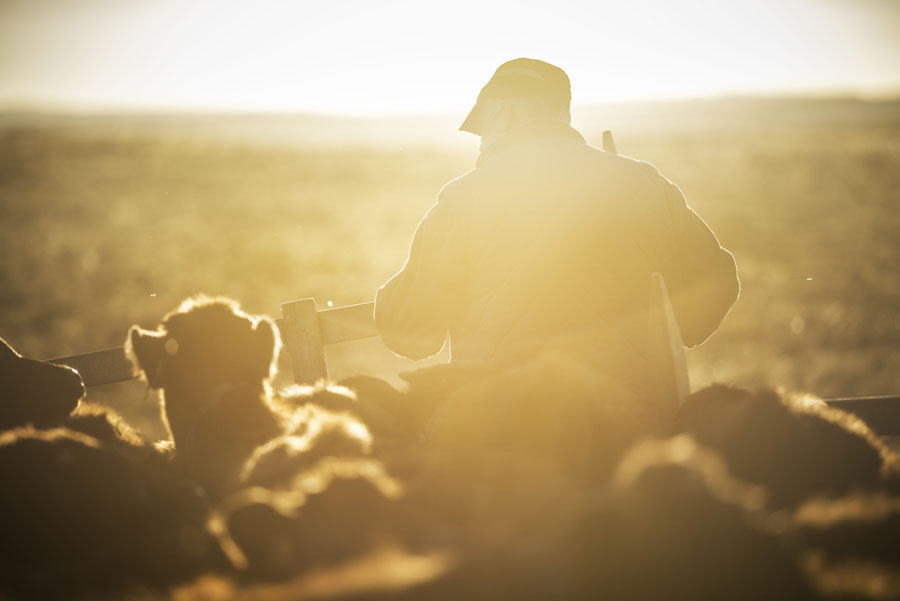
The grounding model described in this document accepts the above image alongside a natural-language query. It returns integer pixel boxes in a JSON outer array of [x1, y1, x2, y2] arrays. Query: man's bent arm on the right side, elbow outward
[[662, 173, 740, 347]]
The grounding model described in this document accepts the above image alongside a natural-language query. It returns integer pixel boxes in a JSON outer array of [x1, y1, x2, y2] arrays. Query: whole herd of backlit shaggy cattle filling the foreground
[[0, 298, 900, 601]]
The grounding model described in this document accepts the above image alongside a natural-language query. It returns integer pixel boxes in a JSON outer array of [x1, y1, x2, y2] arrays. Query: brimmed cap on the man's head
[[459, 58, 572, 136]]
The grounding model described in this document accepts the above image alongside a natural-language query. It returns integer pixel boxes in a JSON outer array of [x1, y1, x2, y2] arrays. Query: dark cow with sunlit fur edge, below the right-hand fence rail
[[675, 386, 896, 509]]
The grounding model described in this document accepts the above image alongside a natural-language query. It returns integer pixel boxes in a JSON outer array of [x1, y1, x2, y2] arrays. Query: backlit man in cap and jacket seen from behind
[[375, 58, 739, 392]]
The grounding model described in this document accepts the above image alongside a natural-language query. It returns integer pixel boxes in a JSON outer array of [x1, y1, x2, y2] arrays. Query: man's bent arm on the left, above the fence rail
[[375, 200, 464, 359]]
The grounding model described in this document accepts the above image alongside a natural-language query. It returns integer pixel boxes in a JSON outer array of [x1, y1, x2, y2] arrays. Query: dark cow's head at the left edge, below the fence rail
[[0, 332, 84, 431]]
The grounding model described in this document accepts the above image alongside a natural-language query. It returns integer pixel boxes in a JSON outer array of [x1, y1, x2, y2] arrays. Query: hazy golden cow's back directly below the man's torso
[[426, 355, 659, 480]]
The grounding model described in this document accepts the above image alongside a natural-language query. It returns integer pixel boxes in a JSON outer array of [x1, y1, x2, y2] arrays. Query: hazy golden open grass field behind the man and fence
[[0, 101, 900, 437]]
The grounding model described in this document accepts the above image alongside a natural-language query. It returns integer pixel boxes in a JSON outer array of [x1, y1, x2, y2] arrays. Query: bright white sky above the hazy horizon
[[0, 0, 900, 114]]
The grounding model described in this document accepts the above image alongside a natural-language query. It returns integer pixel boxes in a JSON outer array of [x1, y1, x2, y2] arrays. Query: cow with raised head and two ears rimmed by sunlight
[[126, 296, 285, 496]]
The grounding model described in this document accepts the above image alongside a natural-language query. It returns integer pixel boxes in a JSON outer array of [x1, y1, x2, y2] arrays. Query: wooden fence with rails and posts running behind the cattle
[[42, 274, 900, 435]]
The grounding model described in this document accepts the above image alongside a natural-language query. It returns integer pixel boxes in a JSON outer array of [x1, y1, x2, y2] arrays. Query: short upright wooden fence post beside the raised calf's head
[[281, 298, 328, 384]]
